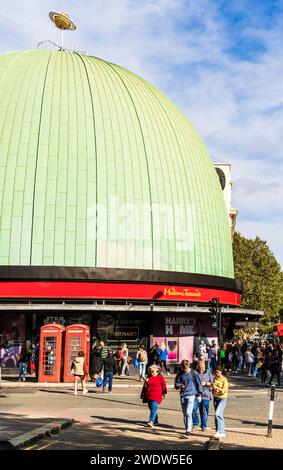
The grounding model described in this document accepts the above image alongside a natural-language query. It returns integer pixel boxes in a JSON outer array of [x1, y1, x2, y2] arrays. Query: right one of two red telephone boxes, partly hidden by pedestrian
[[63, 325, 90, 382]]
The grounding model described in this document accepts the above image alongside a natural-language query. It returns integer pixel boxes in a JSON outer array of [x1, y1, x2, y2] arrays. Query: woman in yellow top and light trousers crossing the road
[[212, 366, 229, 439]]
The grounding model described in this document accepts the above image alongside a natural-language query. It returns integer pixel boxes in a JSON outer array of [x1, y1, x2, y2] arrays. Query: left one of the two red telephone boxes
[[38, 323, 65, 382]]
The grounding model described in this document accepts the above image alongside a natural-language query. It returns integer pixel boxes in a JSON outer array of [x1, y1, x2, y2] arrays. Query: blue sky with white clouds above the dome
[[0, 0, 283, 266]]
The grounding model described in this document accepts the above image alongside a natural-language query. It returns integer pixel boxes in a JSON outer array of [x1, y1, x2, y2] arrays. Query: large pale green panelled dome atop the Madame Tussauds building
[[0, 50, 234, 278]]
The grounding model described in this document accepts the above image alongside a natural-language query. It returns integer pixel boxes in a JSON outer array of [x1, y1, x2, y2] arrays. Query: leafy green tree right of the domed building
[[233, 232, 283, 332]]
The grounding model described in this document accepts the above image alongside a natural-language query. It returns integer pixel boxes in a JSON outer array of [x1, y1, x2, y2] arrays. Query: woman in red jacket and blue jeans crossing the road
[[142, 365, 167, 428]]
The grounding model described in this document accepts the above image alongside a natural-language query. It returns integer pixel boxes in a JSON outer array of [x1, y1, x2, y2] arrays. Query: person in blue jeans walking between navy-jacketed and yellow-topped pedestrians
[[193, 362, 213, 431]]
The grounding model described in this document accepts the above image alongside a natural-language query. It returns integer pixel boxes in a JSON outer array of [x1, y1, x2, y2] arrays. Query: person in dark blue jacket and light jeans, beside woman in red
[[174, 359, 203, 438]]
